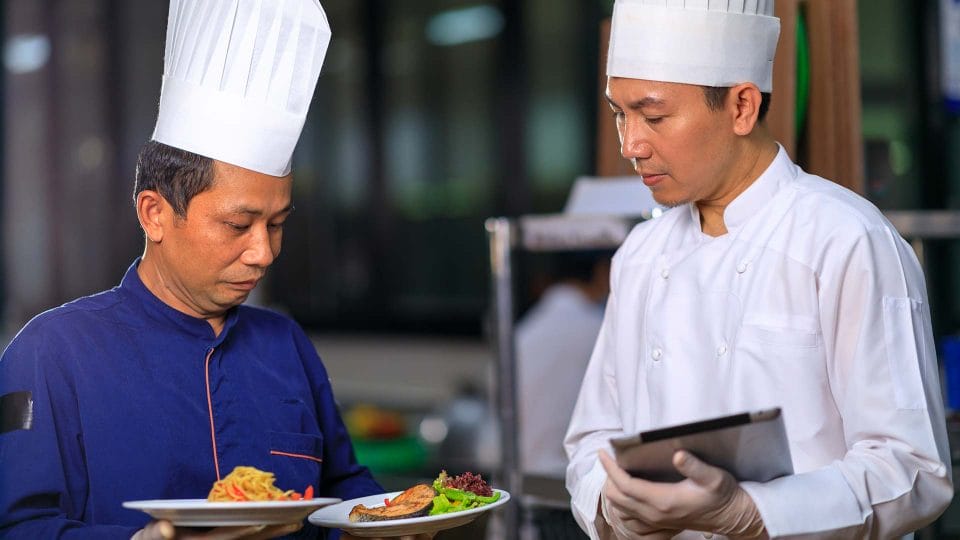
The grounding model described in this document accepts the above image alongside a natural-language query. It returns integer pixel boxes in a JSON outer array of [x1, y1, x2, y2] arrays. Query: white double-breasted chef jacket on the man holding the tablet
[[565, 148, 953, 539]]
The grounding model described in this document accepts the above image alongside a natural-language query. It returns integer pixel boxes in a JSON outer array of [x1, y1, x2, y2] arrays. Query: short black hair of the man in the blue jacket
[[133, 140, 213, 218]]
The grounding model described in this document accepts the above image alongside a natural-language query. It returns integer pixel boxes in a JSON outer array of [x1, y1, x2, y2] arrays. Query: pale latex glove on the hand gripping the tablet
[[600, 450, 767, 538]]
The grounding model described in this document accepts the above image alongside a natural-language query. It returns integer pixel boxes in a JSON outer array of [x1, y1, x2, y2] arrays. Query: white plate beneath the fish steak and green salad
[[310, 489, 510, 536]]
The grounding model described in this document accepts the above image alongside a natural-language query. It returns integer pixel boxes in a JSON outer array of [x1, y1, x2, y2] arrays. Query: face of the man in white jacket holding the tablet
[[606, 77, 735, 206]]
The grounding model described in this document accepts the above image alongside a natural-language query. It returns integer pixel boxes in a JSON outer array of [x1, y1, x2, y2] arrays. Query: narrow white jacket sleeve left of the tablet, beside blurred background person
[[564, 253, 623, 540]]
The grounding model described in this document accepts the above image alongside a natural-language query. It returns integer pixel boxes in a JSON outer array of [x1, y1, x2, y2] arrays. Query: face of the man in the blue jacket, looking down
[[157, 161, 292, 317]]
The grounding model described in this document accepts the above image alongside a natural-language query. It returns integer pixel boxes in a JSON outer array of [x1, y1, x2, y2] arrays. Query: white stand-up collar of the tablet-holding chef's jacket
[[687, 143, 797, 234]]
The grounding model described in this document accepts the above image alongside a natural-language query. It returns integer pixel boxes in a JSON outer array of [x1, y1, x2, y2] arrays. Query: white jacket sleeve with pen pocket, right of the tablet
[[742, 227, 953, 538]]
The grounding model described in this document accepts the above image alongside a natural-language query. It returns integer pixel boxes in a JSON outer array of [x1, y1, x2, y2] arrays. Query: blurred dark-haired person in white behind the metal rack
[[516, 251, 612, 540]]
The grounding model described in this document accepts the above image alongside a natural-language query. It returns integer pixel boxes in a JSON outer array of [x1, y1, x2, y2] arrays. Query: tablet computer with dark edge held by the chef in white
[[610, 408, 793, 482]]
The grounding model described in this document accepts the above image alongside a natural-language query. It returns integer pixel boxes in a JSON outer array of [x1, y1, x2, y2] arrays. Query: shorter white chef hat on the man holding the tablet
[[607, 0, 780, 92]]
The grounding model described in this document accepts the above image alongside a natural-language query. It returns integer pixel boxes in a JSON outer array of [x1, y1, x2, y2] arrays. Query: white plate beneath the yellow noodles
[[123, 498, 342, 527]]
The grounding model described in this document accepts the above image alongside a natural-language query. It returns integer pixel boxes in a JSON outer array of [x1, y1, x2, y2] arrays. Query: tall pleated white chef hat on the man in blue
[[153, 0, 330, 176]]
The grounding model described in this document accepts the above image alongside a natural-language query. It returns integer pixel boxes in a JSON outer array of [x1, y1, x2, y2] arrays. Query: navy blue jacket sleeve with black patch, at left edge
[[0, 325, 137, 539]]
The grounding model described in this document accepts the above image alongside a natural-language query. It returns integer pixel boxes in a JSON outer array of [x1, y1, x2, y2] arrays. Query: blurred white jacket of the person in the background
[[516, 283, 603, 478]]
